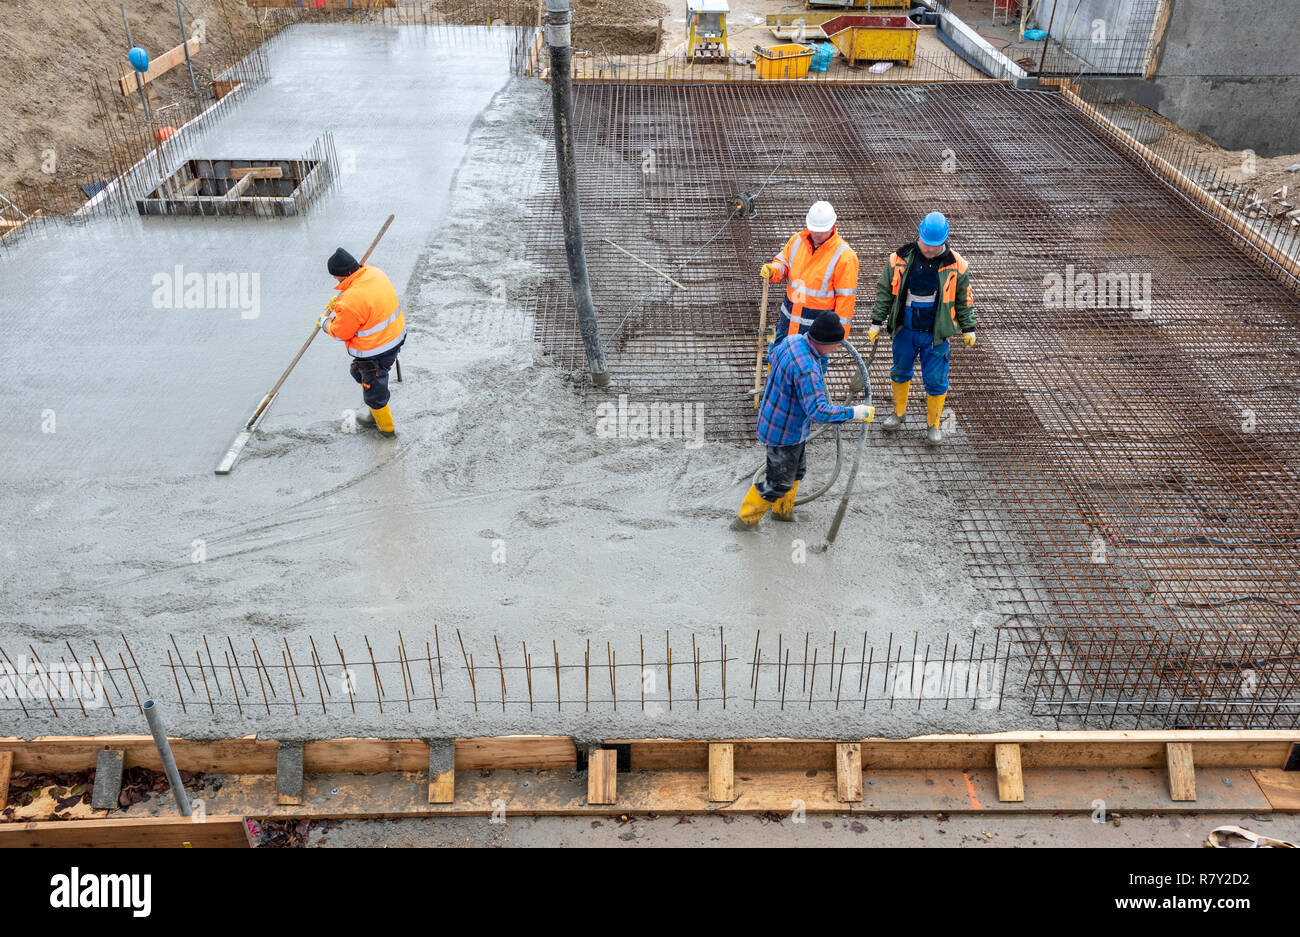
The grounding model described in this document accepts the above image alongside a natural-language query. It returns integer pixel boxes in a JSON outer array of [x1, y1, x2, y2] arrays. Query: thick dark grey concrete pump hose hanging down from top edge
[[546, 0, 610, 387]]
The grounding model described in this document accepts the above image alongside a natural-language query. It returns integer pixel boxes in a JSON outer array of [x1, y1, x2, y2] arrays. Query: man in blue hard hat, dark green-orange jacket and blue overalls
[[867, 212, 975, 446]]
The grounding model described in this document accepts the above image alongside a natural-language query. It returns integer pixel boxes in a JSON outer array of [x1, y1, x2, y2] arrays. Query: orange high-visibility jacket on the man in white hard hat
[[772, 229, 858, 335]]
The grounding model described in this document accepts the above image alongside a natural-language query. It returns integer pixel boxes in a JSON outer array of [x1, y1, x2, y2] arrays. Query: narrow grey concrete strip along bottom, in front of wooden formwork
[[299, 814, 1300, 849]]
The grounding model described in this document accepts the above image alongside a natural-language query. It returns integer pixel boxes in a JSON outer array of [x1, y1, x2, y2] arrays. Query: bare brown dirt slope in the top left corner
[[0, 0, 256, 208]]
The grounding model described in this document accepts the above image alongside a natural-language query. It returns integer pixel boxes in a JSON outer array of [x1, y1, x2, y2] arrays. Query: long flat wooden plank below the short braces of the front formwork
[[137, 769, 1273, 819]]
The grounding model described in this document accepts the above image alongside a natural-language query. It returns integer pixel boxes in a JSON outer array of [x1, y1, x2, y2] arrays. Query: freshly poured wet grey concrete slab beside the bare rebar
[[0, 26, 1019, 739]]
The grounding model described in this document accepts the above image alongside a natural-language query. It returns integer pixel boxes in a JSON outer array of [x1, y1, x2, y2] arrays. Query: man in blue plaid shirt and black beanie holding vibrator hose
[[732, 309, 875, 530]]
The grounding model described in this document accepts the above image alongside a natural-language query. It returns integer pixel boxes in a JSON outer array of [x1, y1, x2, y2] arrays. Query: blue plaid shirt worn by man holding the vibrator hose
[[757, 335, 853, 446]]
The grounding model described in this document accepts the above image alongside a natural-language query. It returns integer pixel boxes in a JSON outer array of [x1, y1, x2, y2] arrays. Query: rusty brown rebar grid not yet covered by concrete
[[528, 83, 1300, 728]]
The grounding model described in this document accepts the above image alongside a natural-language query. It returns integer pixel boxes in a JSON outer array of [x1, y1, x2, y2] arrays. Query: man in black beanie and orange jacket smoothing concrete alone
[[316, 247, 406, 437]]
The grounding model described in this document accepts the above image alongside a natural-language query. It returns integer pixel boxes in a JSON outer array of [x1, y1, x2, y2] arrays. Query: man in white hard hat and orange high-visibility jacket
[[761, 201, 858, 344]]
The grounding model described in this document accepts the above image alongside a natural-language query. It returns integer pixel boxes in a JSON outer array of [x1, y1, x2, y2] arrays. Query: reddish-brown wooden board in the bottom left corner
[[0, 816, 252, 849]]
